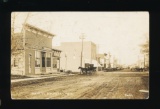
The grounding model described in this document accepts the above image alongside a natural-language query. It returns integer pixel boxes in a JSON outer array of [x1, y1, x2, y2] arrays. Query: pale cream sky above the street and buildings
[[12, 11, 149, 64]]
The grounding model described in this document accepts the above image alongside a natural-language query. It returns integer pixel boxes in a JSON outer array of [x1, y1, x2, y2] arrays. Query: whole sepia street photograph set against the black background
[[10, 11, 149, 100]]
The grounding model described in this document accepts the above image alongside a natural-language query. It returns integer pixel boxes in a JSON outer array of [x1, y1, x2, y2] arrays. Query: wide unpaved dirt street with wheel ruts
[[11, 71, 149, 99]]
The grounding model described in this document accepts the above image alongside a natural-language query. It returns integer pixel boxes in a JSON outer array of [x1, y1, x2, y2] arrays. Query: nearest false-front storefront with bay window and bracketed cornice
[[11, 24, 61, 75]]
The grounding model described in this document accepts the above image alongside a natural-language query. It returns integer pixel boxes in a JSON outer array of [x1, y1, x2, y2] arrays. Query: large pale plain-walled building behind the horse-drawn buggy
[[56, 41, 100, 72]]
